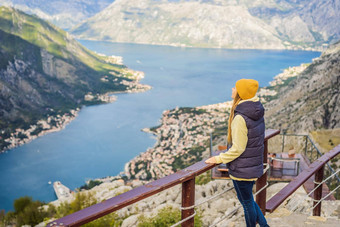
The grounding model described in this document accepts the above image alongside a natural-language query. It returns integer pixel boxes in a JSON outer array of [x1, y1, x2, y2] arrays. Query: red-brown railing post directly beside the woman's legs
[[256, 140, 268, 215]]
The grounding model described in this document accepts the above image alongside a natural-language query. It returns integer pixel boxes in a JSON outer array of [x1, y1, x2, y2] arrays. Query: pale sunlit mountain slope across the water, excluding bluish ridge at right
[[72, 0, 284, 49]]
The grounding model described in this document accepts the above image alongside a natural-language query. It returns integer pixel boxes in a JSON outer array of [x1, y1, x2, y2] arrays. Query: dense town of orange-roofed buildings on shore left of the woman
[[125, 102, 231, 180]]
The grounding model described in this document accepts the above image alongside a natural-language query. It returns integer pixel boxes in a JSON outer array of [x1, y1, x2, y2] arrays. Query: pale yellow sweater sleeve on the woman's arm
[[215, 115, 248, 163]]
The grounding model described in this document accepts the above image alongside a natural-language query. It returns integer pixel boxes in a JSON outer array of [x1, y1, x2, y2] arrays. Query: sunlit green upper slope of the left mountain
[[0, 6, 126, 72]]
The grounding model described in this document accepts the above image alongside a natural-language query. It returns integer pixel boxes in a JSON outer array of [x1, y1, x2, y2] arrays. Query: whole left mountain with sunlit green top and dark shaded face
[[0, 7, 145, 150]]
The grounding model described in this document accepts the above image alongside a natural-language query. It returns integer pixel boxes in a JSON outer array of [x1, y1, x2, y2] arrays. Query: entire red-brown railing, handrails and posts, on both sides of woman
[[47, 129, 340, 227]]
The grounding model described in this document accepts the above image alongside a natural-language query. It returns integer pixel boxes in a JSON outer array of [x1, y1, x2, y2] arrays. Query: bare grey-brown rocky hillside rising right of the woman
[[265, 42, 340, 133]]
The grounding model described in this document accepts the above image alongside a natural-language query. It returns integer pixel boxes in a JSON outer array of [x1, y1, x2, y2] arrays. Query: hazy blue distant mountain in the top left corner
[[0, 0, 114, 29]]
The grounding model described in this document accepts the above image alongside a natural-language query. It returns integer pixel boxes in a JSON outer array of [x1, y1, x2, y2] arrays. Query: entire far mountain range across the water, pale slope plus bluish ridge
[[72, 0, 340, 49]]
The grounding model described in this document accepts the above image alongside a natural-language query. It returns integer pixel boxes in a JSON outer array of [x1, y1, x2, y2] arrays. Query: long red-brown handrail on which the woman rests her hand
[[47, 129, 280, 226]]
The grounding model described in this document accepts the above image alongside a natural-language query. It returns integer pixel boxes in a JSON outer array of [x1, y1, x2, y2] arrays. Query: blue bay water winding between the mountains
[[0, 41, 320, 210]]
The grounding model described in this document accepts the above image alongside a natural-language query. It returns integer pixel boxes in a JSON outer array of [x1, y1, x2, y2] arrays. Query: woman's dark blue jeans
[[233, 180, 269, 227]]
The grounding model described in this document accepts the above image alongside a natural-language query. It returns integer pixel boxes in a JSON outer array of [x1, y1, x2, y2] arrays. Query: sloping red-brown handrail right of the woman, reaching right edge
[[266, 145, 340, 212]]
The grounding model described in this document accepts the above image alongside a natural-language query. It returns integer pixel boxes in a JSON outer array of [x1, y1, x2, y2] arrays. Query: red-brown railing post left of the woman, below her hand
[[182, 178, 195, 227]]
